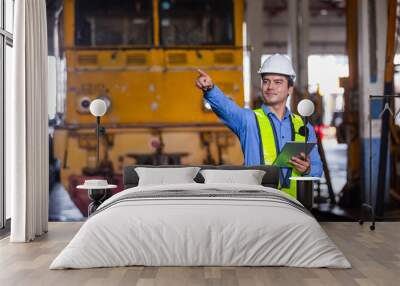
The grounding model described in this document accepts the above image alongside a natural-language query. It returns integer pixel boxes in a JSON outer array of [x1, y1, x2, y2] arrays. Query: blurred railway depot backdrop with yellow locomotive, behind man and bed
[[38, 0, 399, 221]]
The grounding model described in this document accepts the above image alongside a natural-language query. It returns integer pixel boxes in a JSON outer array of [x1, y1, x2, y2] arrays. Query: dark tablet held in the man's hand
[[272, 141, 317, 168]]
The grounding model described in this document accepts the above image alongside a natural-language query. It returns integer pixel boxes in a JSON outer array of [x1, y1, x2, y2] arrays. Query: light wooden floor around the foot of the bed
[[0, 222, 400, 286]]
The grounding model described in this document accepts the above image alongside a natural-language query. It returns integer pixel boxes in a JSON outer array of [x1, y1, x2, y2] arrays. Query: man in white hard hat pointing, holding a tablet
[[196, 54, 322, 198]]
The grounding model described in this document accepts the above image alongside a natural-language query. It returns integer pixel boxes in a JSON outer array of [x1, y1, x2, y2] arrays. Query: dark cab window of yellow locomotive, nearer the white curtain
[[75, 0, 153, 47]]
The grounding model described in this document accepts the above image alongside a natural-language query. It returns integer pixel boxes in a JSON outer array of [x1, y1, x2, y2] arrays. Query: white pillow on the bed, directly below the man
[[200, 170, 265, 185]]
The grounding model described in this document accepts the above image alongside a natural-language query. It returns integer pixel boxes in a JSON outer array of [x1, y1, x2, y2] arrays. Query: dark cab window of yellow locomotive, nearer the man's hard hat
[[159, 0, 234, 46]]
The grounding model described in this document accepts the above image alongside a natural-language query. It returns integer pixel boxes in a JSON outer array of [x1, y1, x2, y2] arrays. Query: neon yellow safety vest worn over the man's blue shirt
[[253, 108, 305, 198]]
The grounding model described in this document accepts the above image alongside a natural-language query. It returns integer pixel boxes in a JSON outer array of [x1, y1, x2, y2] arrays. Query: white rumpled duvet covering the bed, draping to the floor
[[50, 183, 351, 269]]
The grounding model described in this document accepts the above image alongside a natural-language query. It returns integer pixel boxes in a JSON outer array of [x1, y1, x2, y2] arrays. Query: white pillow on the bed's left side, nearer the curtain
[[135, 167, 200, 186]]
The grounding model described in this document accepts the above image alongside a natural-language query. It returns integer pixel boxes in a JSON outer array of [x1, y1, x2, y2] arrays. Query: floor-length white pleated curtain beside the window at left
[[6, 0, 49, 242]]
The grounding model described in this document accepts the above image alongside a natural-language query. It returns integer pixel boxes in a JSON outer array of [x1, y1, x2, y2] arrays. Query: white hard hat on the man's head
[[258, 54, 296, 82]]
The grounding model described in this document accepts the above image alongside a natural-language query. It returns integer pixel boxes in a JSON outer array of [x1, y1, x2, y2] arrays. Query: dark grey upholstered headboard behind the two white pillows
[[123, 165, 279, 189]]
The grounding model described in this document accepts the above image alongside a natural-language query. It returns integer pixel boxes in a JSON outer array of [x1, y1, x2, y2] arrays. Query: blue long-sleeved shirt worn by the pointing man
[[204, 86, 322, 182]]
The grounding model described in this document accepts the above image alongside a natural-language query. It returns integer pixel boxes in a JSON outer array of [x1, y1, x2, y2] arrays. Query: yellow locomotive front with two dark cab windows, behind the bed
[[54, 0, 244, 212]]
